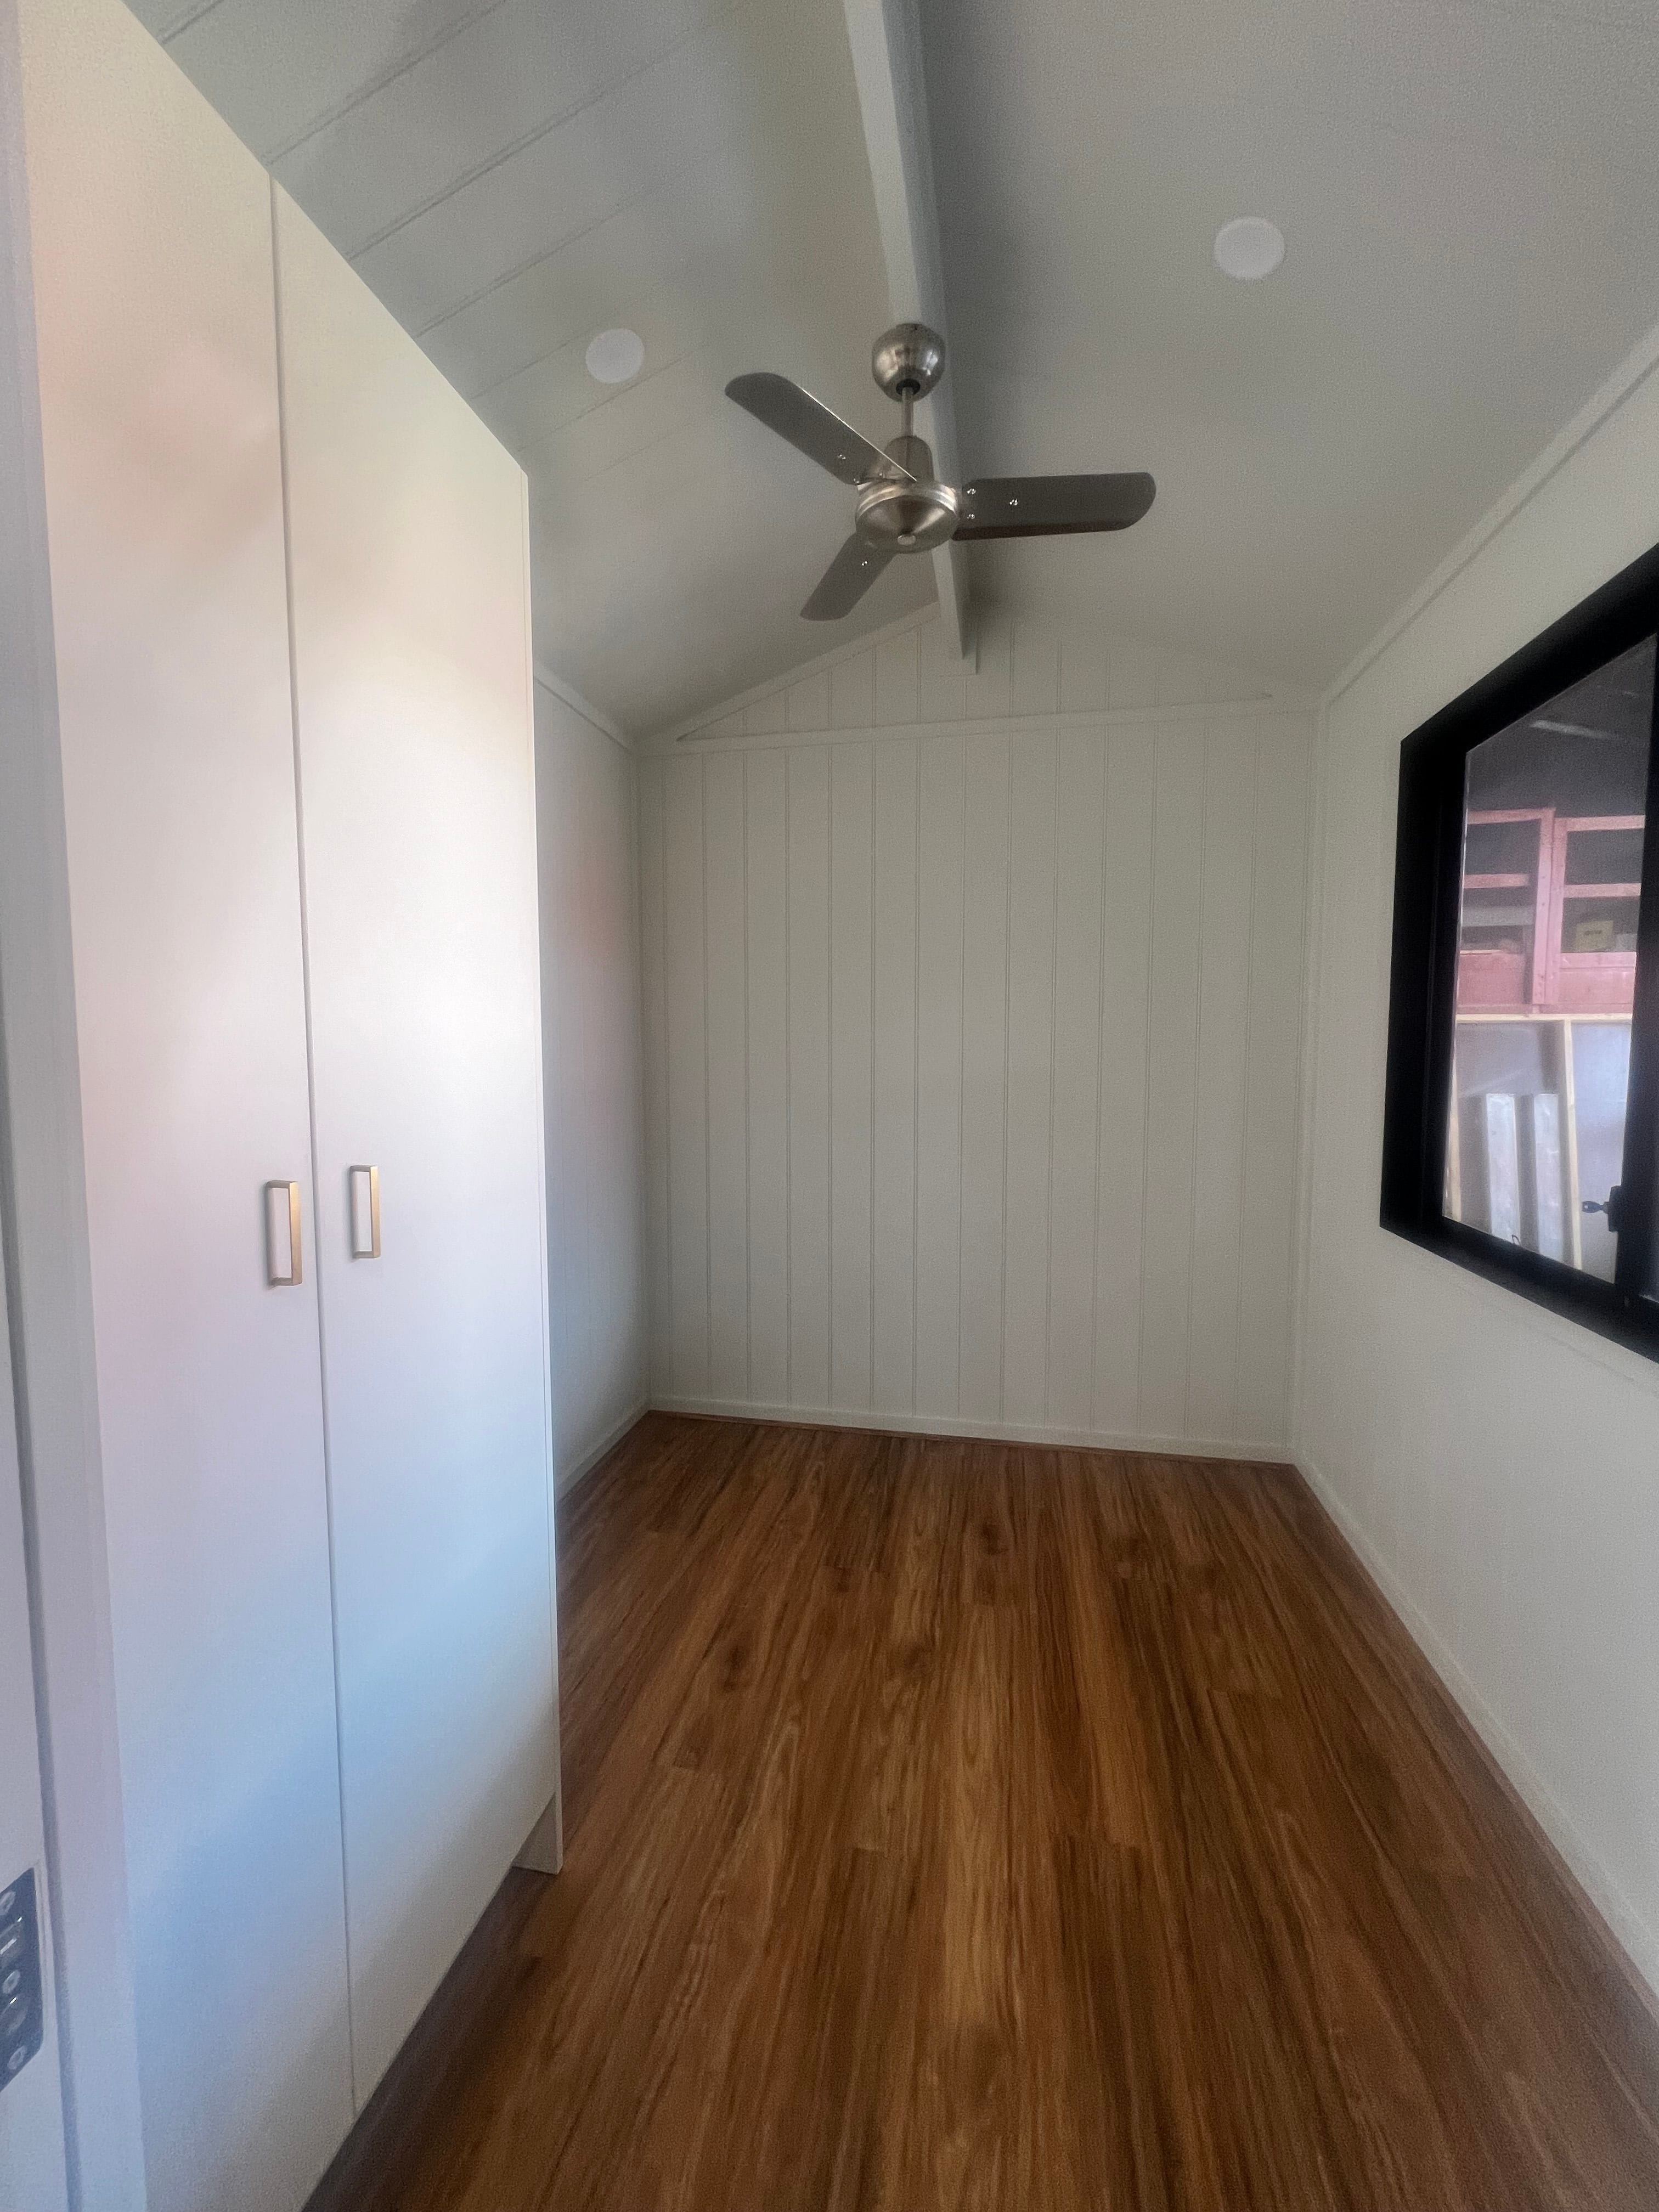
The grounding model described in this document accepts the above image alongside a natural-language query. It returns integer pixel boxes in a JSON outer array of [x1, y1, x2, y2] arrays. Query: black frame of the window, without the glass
[[1383, 546, 1659, 1361]]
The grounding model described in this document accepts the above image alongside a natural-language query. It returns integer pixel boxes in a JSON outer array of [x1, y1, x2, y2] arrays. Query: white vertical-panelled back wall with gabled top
[[639, 619, 1312, 1451]]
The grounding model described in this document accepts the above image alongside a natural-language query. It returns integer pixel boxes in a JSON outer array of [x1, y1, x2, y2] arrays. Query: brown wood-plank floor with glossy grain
[[314, 1415, 1659, 2212]]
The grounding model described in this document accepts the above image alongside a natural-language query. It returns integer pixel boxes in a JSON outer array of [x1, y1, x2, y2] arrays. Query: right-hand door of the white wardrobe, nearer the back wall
[[276, 193, 557, 2099]]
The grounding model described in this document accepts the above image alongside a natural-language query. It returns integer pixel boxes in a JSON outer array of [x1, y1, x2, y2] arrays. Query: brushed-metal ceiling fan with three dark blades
[[725, 323, 1157, 622]]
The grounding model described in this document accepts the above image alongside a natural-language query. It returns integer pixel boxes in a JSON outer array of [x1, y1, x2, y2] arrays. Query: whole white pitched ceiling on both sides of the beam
[[139, 0, 1659, 732]]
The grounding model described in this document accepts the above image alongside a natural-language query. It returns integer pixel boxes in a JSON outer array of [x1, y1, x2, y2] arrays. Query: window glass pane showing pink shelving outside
[[1444, 637, 1655, 1281]]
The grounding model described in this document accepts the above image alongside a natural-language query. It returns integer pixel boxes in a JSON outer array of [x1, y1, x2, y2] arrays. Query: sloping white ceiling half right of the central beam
[[920, 0, 1659, 681]]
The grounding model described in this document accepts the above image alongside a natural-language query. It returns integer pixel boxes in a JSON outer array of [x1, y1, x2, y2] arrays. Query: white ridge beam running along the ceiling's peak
[[843, 0, 969, 657]]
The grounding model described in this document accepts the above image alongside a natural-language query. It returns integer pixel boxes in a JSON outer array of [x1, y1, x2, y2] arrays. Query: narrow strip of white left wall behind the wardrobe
[[535, 684, 646, 1491]]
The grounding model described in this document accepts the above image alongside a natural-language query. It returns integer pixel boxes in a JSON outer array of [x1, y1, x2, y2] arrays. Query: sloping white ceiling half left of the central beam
[[137, 0, 934, 730]]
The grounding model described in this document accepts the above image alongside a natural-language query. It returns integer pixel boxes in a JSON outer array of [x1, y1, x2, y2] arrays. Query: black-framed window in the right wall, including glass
[[1383, 551, 1659, 1358]]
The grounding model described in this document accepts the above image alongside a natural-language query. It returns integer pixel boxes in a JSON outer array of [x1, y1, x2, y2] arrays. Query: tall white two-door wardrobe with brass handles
[[4, 0, 557, 2212]]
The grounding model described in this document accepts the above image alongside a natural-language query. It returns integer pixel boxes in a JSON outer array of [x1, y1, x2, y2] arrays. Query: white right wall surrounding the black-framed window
[[1296, 327, 1659, 1987]]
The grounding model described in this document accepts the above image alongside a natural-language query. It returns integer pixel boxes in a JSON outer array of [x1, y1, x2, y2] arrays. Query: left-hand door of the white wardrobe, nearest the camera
[[22, 0, 349, 2212]]
